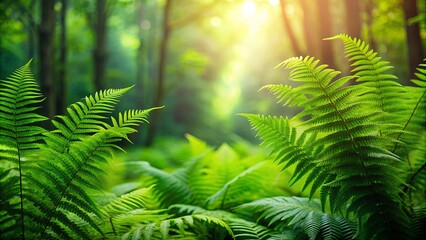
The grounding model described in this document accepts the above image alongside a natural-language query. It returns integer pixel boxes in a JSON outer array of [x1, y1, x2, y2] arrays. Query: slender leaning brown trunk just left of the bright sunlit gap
[[146, 0, 172, 146]]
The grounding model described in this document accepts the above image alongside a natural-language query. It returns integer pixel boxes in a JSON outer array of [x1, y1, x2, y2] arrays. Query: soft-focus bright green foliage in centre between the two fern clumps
[[134, 136, 282, 210]]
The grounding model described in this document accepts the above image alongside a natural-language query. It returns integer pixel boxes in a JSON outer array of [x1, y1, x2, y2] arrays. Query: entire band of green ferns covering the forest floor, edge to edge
[[0, 35, 426, 240]]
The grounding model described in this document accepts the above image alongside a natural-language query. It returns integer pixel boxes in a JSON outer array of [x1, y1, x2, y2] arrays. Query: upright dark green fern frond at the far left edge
[[0, 60, 46, 238]]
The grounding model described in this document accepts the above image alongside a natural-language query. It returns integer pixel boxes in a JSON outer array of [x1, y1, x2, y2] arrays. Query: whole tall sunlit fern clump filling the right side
[[243, 35, 426, 239]]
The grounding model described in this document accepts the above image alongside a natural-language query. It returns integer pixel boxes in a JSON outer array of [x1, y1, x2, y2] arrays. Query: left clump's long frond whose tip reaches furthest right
[[26, 105, 159, 238]]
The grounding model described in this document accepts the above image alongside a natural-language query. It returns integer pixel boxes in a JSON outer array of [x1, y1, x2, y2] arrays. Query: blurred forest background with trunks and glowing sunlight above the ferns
[[0, 0, 426, 146]]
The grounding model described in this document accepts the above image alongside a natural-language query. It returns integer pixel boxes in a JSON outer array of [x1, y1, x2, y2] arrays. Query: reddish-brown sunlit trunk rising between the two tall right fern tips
[[317, 0, 335, 68]]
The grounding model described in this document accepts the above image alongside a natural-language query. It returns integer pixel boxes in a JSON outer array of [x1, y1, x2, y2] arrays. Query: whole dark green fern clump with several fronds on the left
[[0, 62, 160, 239]]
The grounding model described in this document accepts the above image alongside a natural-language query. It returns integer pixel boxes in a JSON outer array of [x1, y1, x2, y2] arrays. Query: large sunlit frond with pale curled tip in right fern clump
[[284, 55, 406, 237]]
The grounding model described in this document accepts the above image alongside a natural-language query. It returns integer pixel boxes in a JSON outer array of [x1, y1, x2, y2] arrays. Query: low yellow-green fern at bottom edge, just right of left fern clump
[[102, 189, 232, 239]]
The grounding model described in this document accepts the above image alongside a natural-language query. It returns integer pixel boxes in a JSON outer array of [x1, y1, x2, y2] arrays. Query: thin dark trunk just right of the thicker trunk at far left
[[57, 0, 67, 114]]
